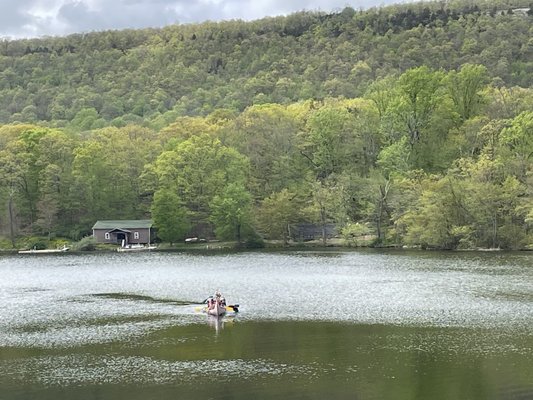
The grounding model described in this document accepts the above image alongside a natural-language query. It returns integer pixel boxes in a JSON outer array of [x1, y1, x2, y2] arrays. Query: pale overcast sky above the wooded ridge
[[0, 0, 400, 38]]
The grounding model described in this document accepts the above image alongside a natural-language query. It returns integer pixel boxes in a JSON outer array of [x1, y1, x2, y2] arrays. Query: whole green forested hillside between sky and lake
[[0, 1, 533, 249]]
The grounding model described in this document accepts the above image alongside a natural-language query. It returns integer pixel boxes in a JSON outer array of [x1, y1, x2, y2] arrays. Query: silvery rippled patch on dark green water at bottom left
[[0, 354, 314, 386]]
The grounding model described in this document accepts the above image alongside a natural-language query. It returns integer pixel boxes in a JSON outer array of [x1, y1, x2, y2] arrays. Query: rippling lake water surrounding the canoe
[[0, 250, 533, 400]]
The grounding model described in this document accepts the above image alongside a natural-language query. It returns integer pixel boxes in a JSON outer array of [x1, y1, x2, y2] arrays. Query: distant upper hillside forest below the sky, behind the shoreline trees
[[0, 1, 532, 126]]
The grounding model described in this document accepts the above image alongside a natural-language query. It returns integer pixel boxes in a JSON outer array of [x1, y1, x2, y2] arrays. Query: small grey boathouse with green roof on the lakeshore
[[93, 219, 154, 247]]
